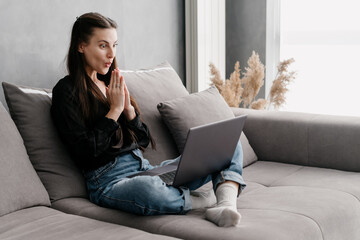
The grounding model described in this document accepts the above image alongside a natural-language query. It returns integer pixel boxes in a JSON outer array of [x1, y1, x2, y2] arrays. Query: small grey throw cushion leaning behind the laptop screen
[[158, 87, 257, 167]]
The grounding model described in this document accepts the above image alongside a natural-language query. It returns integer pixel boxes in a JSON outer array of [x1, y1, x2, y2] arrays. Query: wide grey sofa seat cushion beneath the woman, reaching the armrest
[[53, 161, 360, 240]]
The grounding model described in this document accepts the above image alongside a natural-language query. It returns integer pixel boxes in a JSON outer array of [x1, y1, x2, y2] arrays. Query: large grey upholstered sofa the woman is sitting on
[[0, 63, 360, 240]]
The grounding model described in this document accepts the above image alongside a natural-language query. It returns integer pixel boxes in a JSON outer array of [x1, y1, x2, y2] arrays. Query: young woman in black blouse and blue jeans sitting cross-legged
[[51, 13, 245, 227]]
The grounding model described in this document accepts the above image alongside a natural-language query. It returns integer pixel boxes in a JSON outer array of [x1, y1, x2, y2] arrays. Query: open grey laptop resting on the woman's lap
[[129, 115, 247, 187]]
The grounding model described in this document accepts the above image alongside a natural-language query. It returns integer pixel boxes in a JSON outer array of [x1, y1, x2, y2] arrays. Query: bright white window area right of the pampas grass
[[280, 0, 360, 116]]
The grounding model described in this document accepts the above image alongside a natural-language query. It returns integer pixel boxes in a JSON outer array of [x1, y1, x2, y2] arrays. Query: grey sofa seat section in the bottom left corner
[[0, 207, 178, 240]]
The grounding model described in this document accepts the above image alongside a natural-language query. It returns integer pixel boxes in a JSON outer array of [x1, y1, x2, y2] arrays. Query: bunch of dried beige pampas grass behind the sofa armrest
[[209, 51, 295, 110]]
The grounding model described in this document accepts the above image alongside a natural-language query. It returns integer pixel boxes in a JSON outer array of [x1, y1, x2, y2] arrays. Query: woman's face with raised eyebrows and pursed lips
[[79, 28, 117, 78]]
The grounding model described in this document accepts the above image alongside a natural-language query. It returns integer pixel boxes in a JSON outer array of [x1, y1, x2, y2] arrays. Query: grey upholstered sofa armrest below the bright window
[[232, 108, 360, 172]]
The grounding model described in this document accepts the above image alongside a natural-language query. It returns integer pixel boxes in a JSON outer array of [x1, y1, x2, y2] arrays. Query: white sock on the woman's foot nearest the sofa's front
[[205, 183, 241, 227]]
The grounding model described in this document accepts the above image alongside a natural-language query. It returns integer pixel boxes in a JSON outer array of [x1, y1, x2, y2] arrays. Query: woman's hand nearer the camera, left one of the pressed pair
[[106, 69, 126, 121]]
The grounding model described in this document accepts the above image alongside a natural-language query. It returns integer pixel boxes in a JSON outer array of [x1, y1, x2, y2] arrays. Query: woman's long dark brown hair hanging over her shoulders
[[67, 13, 156, 150]]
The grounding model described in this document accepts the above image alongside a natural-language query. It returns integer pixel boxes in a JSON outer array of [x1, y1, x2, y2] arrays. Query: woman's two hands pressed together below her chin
[[106, 68, 136, 121]]
